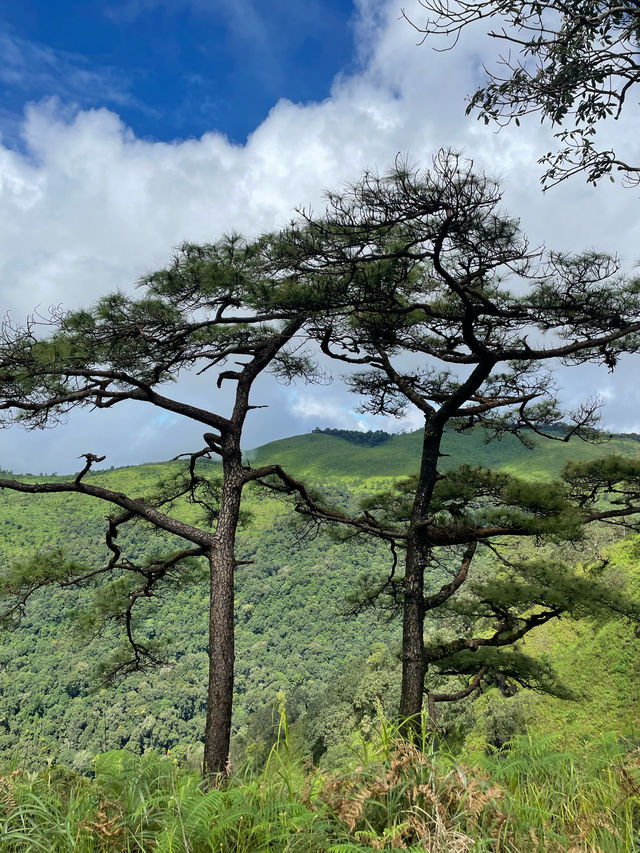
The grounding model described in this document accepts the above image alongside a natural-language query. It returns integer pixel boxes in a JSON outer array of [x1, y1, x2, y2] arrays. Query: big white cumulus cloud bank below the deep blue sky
[[0, 0, 640, 470]]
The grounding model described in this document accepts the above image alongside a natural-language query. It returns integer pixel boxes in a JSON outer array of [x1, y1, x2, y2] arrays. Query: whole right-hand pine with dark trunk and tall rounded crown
[[266, 151, 640, 718]]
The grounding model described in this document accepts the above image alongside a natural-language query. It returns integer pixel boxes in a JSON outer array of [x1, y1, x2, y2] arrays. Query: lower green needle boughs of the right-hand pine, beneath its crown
[[355, 446, 640, 701]]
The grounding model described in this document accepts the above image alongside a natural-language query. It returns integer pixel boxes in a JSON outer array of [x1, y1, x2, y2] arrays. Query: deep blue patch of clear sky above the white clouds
[[0, 0, 355, 143]]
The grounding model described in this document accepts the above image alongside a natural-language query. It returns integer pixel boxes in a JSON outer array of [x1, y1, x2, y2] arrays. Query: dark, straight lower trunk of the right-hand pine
[[400, 422, 442, 732]]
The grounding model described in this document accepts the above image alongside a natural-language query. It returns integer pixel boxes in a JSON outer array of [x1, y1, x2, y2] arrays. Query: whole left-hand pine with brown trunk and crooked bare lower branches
[[0, 237, 314, 777]]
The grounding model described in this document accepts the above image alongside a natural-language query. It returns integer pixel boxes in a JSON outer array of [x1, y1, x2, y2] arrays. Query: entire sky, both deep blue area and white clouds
[[0, 0, 640, 472]]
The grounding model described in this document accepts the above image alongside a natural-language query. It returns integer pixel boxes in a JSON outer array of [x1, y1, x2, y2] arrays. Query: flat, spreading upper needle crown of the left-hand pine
[[0, 237, 314, 428]]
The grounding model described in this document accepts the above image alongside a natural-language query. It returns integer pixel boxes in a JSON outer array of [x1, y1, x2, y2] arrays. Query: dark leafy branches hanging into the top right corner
[[403, 0, 640, 186]]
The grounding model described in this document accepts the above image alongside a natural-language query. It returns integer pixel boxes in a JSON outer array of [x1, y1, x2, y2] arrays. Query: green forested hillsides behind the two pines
[[0, 430, 640, 769]]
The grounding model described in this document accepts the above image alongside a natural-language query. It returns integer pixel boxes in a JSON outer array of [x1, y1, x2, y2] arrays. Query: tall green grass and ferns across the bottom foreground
[[0, 708, 640, 853]]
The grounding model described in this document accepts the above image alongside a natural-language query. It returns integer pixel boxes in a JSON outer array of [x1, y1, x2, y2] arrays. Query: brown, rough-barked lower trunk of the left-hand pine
[[203, 440, 243, 781]]
